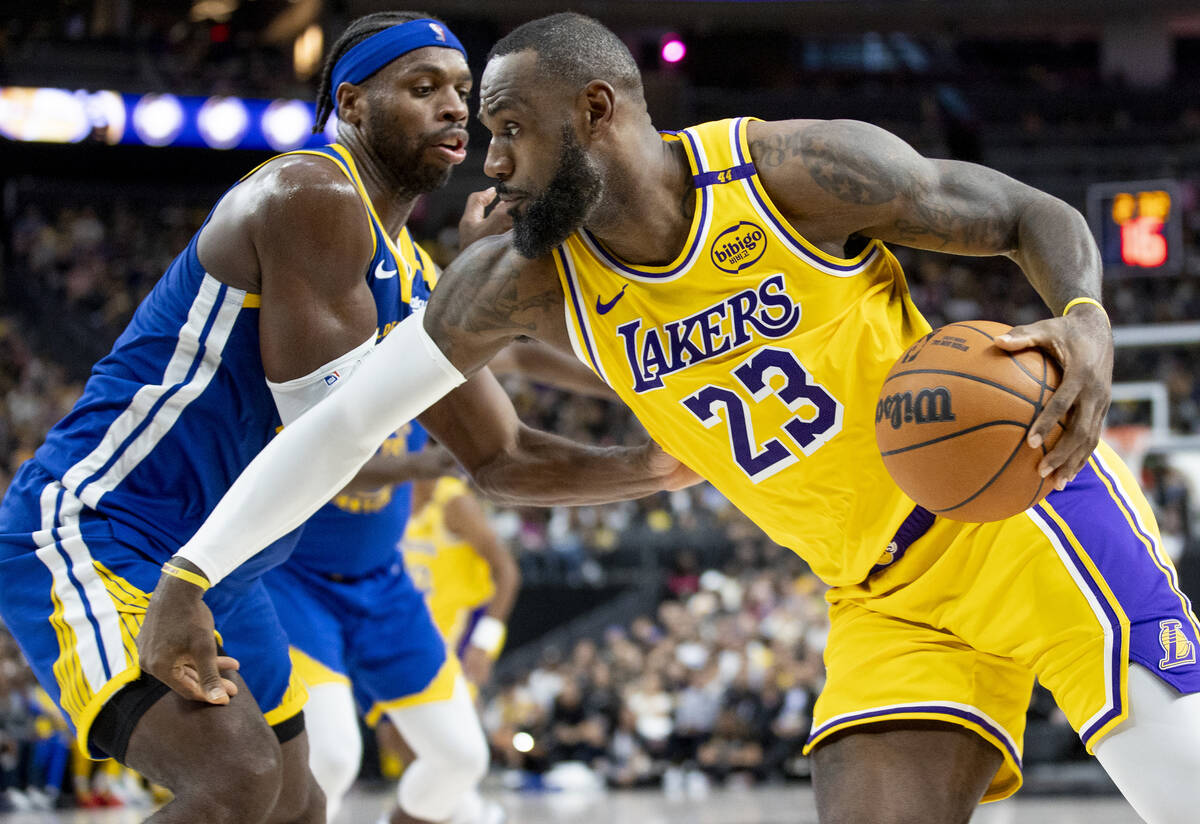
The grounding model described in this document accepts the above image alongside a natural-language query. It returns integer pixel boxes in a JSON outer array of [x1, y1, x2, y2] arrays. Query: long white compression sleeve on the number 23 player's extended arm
[[179, 312, 466, 584]]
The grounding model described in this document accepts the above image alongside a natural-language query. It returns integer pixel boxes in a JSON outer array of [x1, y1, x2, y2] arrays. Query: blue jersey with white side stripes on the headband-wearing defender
[[23, 144, 428, 576]]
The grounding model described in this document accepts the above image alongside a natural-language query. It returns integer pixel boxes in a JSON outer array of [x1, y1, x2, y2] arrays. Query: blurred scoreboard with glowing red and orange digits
[[1087, 180, 1183, 277]]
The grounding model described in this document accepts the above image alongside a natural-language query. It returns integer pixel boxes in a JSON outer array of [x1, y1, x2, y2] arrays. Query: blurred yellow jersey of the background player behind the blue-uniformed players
[[403, 477, 496, 649]]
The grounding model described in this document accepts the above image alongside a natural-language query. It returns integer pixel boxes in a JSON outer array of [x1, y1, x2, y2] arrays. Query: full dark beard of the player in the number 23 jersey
[[508, 124, 604, 259]]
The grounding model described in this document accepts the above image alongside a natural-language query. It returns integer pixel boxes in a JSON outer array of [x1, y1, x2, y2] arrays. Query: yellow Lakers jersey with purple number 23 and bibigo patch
[[554, 118, 930, 585]]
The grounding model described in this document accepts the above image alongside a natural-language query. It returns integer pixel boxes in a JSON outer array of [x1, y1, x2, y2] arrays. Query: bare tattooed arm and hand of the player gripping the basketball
[[749, 120, 1112, 488]]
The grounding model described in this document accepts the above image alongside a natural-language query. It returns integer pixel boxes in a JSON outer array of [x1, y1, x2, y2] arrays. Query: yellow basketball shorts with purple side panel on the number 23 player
[[805, 444, 1200, 801]]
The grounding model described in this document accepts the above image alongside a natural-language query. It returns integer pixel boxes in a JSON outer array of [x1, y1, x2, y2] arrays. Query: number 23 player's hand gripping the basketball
[[996, 303, 1112, 489]]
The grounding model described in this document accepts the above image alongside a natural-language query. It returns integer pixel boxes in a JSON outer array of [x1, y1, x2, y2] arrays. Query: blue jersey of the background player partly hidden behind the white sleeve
[[288, 421, 428, 577]]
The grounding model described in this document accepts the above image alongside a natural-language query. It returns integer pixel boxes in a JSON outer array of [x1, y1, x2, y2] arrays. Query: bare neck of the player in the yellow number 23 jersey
[[588, 127, 696, 265]]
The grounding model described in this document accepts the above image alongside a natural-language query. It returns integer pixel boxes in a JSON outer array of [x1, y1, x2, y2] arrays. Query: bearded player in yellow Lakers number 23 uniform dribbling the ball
[[164, 13, 1200, 824]]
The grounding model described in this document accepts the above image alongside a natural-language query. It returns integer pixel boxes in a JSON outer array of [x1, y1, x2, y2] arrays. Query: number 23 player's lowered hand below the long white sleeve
[[138, 560, 239, 704]]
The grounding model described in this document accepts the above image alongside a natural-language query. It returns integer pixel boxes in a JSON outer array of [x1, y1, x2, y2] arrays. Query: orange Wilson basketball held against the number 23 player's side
[[875, 320, 1062, 522]]
